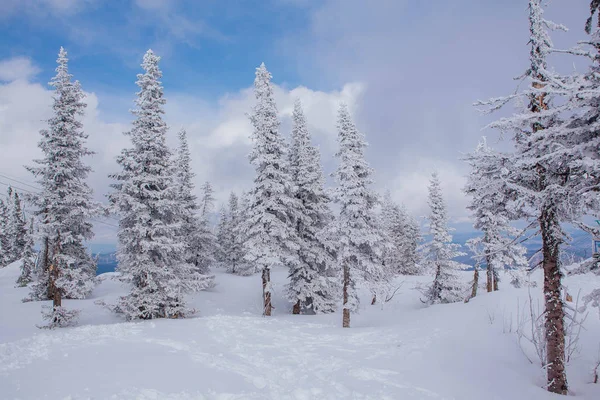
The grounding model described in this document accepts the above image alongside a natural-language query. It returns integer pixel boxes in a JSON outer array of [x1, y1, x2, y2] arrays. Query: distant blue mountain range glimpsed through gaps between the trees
[[94, 230, 592, 275]]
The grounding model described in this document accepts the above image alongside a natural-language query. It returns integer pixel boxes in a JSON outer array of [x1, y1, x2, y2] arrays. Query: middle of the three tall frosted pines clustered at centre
[[287, 99, 338, 314]]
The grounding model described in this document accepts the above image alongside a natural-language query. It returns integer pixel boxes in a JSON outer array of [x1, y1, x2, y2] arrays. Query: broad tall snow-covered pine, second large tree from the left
[[110, 50, 212, 320]]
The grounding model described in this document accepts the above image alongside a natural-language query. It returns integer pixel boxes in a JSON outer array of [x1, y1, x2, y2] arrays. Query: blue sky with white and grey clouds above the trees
[[0, 0, 589, 243]]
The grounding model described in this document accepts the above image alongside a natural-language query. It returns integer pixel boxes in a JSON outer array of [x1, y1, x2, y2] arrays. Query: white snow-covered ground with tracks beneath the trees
[[0, 264, 600, 400]]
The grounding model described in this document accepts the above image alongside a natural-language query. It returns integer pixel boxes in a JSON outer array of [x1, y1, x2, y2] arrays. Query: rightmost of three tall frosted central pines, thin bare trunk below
[[334, 104, 386, 328]]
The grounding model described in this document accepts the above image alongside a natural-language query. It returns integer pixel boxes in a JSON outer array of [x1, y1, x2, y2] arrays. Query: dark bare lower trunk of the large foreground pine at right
[[540, 206, 567, 394]]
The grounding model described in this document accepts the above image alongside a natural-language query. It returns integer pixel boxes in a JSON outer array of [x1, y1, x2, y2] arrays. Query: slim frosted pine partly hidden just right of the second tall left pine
[[175, 129, 214, 275]]
